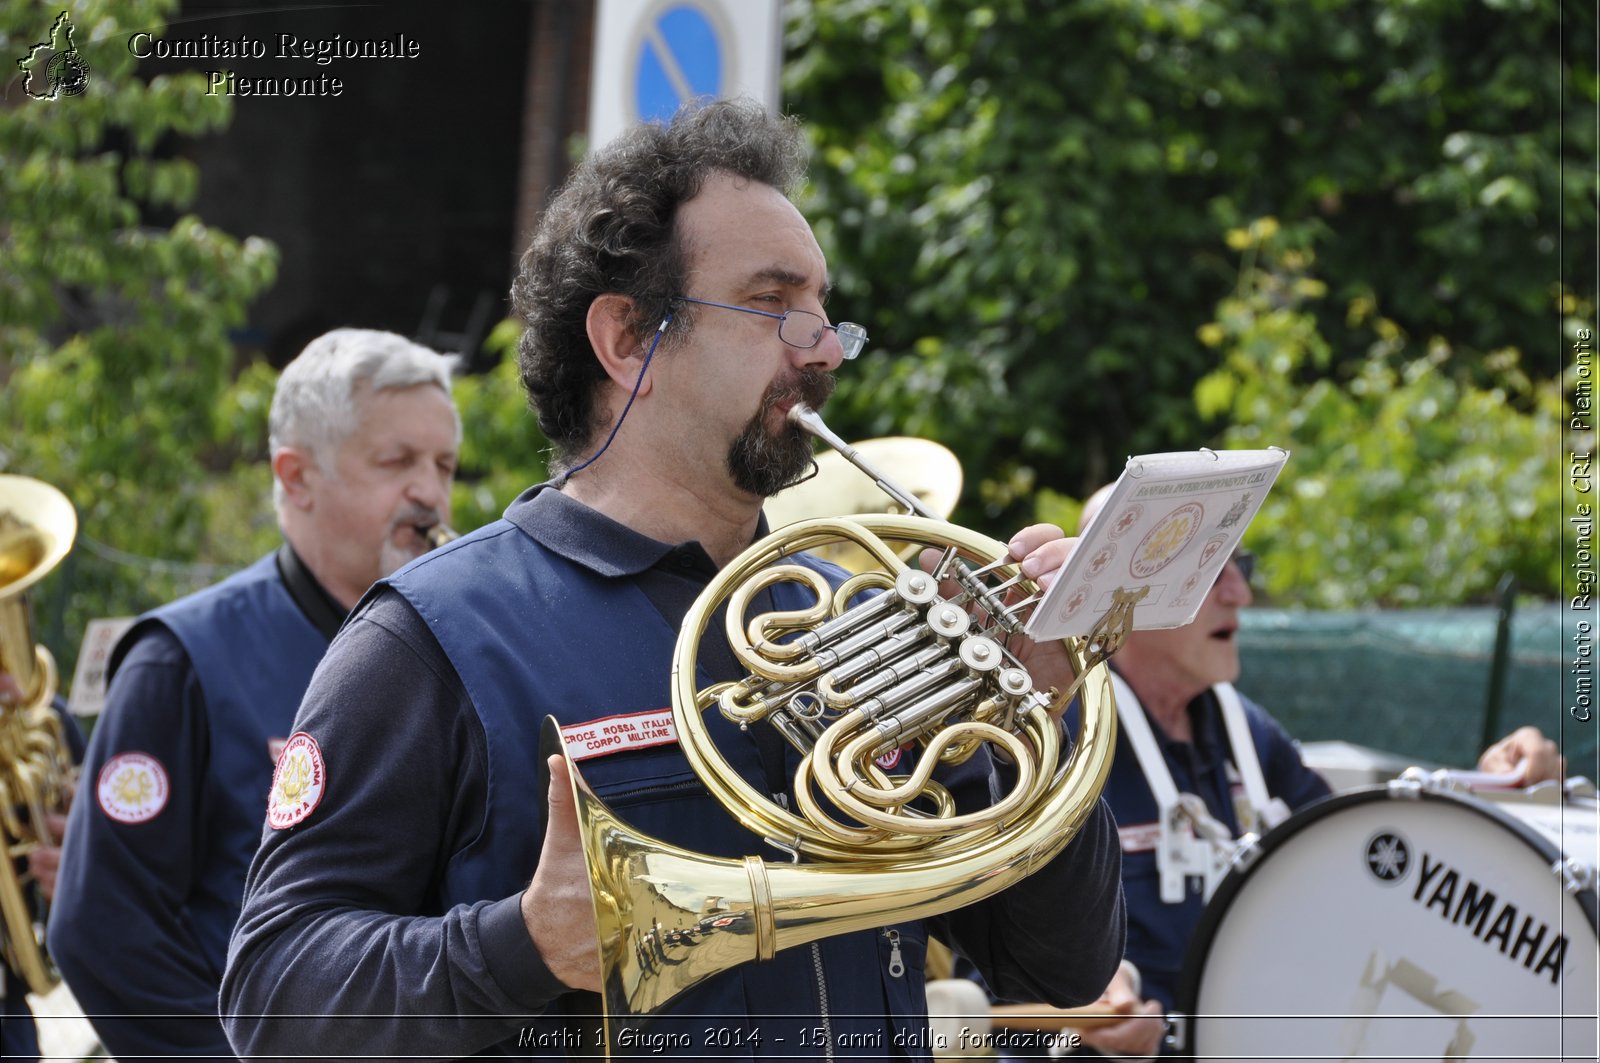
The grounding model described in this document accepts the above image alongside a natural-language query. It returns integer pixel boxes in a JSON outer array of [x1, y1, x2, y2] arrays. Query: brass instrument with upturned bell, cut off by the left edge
[[0, 475, 78, 993]]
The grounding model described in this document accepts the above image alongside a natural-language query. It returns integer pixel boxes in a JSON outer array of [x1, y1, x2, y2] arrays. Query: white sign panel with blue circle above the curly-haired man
[[589, 0, 782, 151]]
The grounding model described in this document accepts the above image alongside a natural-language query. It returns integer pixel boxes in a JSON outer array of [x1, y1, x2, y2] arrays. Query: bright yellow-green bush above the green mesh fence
[[1195, 219, 1562, 608]]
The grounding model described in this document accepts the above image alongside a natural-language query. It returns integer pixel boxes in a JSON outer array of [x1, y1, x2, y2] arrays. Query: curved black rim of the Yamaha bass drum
[[1173, 784, 1600, 1052]]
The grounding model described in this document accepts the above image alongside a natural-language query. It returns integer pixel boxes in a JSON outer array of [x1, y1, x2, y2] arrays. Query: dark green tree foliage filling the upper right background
[[786, 0, 1597, 557]]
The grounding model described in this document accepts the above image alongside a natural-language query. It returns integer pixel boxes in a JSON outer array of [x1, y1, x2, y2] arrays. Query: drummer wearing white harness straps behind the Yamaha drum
[[985, 485, 1566, 1057]]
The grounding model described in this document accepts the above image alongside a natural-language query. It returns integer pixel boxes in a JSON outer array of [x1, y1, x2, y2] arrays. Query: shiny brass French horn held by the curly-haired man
[[556, 407, 1115, 1044]]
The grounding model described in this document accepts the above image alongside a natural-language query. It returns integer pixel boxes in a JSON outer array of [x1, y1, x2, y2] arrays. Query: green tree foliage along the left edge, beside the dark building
[[0, 0, 277, 666]]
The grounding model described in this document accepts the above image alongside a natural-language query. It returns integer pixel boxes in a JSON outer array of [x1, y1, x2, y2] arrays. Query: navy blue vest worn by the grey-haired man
[[120, 552, 328, 970]]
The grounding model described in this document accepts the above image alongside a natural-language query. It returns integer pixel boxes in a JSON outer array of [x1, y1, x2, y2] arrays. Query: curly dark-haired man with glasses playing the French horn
[[222, 101, 1123, 1060]]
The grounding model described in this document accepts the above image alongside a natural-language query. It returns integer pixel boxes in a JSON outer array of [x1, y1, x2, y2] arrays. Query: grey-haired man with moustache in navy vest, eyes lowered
[[50, 328, 461, 1058]]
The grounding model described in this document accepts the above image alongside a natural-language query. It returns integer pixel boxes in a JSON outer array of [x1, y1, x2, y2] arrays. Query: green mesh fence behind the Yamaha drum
[[1238, 604, 1580, 776]]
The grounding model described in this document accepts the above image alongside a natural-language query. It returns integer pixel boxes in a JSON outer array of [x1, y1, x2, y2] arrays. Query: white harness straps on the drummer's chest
[[1110, 672, 1290, 905]]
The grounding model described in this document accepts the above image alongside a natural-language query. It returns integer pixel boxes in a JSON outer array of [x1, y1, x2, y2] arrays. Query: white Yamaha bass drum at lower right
[[1174, 783, 1600, 1063]]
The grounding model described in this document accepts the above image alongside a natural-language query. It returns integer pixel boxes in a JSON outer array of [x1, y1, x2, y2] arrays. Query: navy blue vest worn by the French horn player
[[390, 520, 930, 1058]]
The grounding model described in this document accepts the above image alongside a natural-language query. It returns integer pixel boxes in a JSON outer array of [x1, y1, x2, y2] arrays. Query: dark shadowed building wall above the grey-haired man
[[142, 0, 592, 365]]
